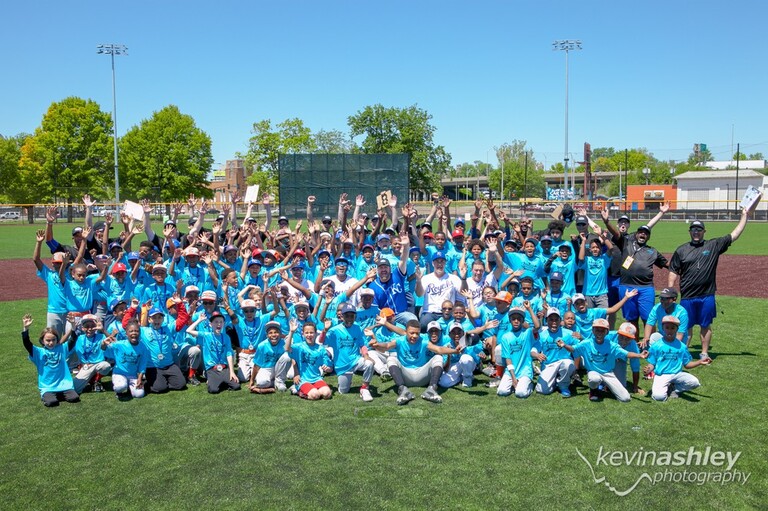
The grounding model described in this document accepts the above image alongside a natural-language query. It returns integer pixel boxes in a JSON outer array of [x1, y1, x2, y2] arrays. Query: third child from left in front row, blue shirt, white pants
[[101, 320, 149, 400]]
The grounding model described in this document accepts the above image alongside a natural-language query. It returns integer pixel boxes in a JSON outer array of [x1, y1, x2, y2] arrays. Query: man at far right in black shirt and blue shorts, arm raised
[[667, 200, 760, 359]]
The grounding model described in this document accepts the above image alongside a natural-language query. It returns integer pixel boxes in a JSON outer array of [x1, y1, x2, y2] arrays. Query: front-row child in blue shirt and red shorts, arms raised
[[285, 319, 332, 401]]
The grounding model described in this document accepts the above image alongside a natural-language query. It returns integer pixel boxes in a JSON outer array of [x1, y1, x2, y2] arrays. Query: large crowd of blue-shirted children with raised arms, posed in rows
[[22, 195, 711, 406]]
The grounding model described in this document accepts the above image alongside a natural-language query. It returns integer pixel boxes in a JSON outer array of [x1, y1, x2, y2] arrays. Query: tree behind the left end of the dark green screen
[[244, 118, 320, 199]]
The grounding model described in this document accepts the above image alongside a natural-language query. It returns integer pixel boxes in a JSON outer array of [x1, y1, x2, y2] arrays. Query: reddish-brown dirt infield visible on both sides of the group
[[0, 254, 768, 302]]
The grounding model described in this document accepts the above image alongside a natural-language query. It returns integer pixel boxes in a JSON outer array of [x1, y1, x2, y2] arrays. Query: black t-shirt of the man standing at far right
[[669, 234, 733, 298]]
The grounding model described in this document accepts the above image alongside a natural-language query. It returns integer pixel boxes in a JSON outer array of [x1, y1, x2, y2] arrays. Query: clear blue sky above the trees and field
[[0, 0, 768, 171]]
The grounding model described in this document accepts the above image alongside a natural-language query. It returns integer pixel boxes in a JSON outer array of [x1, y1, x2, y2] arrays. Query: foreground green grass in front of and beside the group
[[0, 297, 768, 510]]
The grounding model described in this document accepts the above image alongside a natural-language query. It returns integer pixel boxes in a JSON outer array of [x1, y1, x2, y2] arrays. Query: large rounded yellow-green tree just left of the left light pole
[[18, 97, 114, 221]]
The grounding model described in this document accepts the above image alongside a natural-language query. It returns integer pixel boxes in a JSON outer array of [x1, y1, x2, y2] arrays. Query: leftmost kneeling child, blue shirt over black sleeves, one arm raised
[[21, 314, 80, 407]]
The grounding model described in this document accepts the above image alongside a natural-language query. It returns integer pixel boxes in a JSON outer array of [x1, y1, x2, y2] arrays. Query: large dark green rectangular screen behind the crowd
[[279, 154, 410, 219]]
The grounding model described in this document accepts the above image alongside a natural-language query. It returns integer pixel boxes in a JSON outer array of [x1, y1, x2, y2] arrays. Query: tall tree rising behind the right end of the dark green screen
[[347, 104, 451, 193]]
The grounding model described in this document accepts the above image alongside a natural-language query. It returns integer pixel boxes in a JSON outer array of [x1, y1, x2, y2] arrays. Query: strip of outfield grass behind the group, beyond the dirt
[[0, 220, 768, 259]]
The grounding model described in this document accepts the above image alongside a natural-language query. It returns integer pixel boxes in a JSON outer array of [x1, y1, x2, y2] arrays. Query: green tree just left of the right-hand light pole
[[489, 140, 546, 199]]
